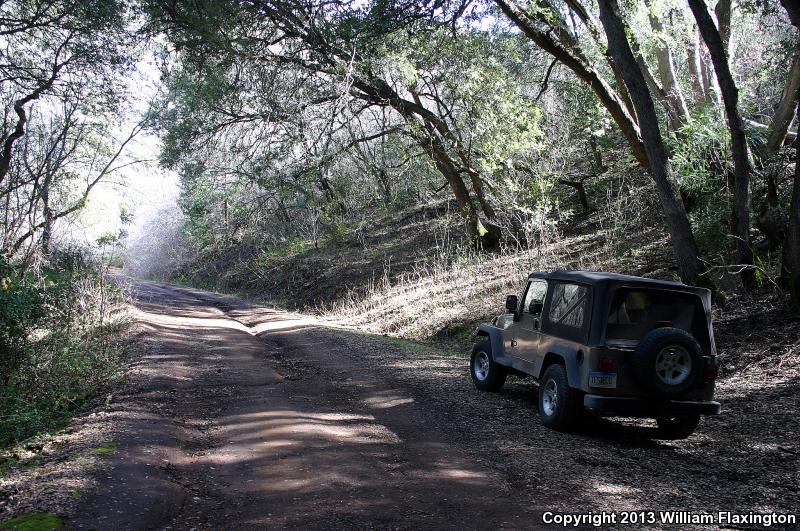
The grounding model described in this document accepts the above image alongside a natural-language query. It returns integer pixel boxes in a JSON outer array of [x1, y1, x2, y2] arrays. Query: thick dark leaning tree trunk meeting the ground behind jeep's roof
[[599, 0, 708, 284]]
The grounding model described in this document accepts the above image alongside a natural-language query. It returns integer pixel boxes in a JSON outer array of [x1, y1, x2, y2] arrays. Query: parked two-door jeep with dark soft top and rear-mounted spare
[[470, 271, 720, 439]]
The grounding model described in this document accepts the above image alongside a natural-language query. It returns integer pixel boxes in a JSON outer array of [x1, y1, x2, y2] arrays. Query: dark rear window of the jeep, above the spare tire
[[606, 288, 709, 348]]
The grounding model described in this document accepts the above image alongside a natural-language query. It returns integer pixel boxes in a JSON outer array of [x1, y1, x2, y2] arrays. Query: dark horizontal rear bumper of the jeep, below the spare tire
[[583, 395, 722, 417]]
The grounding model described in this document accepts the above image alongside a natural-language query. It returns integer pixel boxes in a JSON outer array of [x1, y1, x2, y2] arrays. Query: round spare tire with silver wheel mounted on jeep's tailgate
[[631, 327, 703, 397]]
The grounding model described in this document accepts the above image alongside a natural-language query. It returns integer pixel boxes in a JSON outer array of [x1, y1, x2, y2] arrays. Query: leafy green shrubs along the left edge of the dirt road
[[0, 248, 125, 445]]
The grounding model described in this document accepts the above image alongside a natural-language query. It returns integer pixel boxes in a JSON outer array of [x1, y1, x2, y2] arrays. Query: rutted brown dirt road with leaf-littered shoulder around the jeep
[[65, 282, 799, 529]]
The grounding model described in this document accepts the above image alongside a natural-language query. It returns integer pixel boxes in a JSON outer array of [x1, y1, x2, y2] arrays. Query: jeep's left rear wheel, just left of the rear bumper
[[539, 365, 583, 430]]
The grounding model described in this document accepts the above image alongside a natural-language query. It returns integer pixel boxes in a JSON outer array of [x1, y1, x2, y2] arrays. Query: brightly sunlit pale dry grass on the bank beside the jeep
[[320, 229, 597, 340]]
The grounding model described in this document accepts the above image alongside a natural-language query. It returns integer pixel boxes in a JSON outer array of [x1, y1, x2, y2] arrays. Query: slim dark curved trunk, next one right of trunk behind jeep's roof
[[689, 0, 755, 289]]
